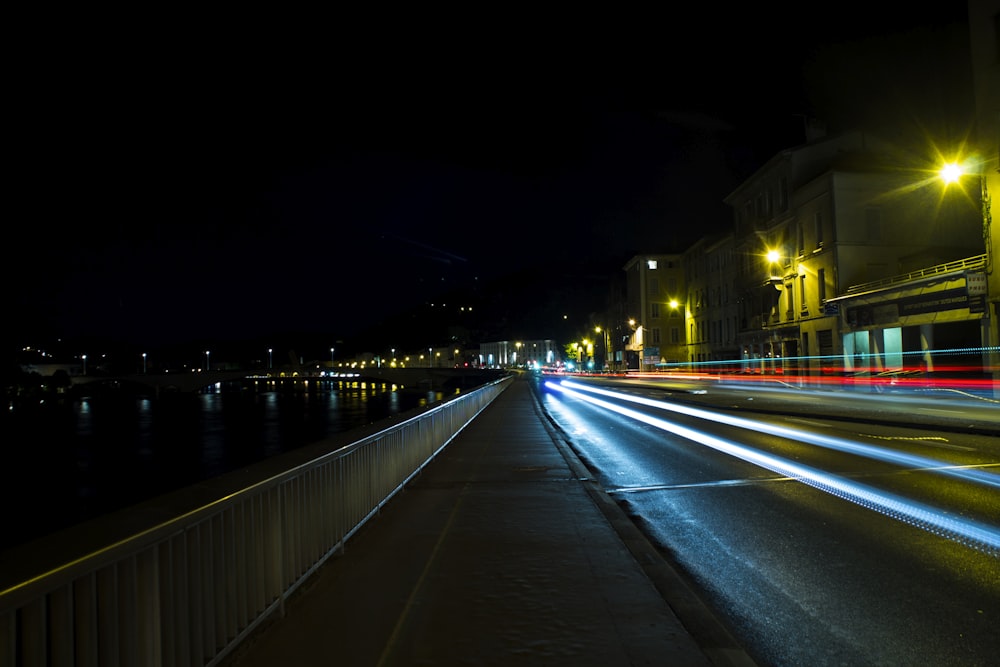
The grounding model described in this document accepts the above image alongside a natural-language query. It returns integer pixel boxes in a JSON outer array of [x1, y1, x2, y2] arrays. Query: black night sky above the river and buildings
[[5, 2, 967, 354]]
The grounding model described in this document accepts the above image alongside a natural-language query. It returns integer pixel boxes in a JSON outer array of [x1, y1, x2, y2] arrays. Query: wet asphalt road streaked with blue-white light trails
[[542, 379, 1000, 666]]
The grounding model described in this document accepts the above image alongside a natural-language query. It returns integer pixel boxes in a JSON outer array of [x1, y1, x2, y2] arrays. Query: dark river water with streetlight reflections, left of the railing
[[0, 383, 441, 549]]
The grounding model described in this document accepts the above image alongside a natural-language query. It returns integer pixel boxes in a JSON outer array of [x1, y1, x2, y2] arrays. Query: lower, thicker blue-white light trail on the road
[[545, 382, 1000, 555]]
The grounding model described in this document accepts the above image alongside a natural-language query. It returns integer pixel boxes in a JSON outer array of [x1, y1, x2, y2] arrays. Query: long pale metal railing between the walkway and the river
[[0, 377, 511, 667]]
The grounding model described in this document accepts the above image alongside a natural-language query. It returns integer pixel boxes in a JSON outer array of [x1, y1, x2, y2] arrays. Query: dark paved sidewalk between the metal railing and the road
[[223, 379, 753, 667]]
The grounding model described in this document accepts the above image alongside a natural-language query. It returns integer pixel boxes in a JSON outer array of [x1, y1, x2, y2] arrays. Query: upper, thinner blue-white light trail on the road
[[546, 380, 1000, 489]]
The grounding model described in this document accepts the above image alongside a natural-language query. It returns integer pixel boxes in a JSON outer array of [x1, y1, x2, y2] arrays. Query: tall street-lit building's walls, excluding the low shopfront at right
[[720, 134, 983, 372]]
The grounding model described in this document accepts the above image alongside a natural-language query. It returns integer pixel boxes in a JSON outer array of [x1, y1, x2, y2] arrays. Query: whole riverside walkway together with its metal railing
[[0, 376, 754, 667]]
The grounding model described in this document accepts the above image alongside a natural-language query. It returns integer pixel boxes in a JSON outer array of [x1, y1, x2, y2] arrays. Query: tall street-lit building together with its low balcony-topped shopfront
[[712, 133, 984, 374]]
